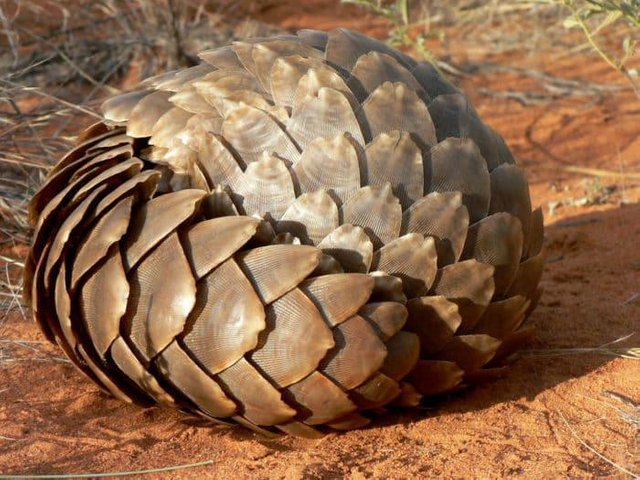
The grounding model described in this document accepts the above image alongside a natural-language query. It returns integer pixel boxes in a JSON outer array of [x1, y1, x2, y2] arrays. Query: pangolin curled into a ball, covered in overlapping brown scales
[[25, 29, 543, 437]]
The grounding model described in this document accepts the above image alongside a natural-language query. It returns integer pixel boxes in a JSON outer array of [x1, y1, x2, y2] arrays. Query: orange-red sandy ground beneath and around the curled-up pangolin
[[0, 1, 640, 479]]
